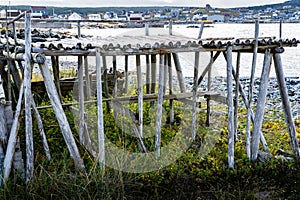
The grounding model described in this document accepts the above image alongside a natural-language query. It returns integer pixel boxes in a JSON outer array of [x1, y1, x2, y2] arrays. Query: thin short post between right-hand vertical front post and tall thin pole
[[234, 51, 241, 139]]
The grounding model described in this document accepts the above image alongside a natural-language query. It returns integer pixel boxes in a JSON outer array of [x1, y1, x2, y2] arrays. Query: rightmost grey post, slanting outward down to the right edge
[[273, 53, 300, 157]]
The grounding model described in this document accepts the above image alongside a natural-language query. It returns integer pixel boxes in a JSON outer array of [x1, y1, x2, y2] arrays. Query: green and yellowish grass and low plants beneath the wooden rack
[[0, 96, 300, 199]]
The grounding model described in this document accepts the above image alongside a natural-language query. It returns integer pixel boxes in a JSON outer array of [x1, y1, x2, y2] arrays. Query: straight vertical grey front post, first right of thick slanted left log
[[96, 48, 105, 169]]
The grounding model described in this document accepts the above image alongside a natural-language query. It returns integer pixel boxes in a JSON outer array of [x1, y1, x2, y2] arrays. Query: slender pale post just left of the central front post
[[136, 55, 143, 137]]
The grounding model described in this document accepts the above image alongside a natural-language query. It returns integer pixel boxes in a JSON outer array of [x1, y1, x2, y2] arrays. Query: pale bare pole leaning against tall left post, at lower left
[[3, 85, 24, 180]]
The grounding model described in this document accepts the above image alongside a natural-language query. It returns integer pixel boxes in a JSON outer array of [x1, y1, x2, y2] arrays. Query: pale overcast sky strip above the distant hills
[[0, 0, 284, 8]]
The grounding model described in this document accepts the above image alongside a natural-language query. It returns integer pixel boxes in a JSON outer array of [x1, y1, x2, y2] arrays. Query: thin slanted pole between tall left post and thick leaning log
[[31, 96, 51, 160]]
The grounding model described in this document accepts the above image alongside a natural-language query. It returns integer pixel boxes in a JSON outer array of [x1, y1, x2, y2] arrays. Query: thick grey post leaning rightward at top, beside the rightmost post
[[251, 50, 271, 161]]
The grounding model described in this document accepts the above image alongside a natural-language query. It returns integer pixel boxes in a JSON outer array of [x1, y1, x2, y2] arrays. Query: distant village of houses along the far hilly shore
[[0, 4, 300, 26]]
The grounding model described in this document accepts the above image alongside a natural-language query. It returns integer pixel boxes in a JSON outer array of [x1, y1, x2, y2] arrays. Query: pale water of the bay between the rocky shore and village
[[52, 23, 300, 77]]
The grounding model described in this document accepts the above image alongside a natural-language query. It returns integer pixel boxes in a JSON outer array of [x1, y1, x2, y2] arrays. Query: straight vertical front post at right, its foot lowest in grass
[[226, 46, 234, 169]]
